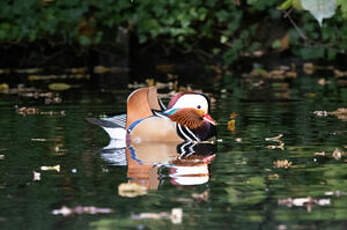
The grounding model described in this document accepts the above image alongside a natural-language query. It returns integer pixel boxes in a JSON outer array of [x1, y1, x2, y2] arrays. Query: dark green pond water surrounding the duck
[[0, 76, 347, 230]]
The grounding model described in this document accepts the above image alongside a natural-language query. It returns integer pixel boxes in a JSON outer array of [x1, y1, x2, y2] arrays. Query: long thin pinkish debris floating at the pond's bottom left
[[52, 206, 113, 216]]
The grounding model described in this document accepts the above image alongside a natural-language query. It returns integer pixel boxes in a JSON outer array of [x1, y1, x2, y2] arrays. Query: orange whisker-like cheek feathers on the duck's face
[[169, 108, 204, 129]]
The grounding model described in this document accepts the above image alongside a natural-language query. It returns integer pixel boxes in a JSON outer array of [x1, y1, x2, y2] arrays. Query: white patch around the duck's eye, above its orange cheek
[[172, 94, 208, 113]]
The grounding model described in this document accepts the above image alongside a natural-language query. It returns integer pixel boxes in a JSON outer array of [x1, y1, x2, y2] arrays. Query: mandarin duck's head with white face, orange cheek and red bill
[[165, 92, 216, 129]]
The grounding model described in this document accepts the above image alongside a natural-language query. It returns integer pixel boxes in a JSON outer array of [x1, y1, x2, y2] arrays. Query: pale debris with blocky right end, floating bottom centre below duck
[[131, 208, 183, 224]]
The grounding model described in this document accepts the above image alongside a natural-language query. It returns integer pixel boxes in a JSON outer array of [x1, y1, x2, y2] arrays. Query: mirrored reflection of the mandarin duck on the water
[[101, 140, 216, 190]]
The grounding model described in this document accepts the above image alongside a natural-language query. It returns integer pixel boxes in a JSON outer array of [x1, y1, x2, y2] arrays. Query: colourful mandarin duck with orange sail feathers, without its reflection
[[87, 87, 216, 145]]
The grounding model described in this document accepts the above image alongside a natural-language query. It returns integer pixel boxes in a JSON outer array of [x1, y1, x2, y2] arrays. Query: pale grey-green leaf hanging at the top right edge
[[301, 0, 336, 26]]
